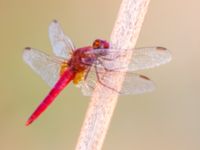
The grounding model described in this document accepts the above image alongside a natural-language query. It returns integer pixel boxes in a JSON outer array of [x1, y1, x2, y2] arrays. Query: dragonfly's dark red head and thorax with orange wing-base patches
[[60, 39, 109, 84]]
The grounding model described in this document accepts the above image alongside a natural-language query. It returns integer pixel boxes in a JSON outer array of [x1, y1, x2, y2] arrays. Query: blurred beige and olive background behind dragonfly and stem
[[0, 0, 200, 150]]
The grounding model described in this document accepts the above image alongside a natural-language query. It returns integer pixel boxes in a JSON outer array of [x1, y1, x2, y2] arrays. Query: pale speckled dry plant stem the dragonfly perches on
[[76, 0, 150, 150]]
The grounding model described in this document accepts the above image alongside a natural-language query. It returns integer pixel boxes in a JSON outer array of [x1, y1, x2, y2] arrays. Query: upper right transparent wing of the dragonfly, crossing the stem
[[99, 47, 171, 71]]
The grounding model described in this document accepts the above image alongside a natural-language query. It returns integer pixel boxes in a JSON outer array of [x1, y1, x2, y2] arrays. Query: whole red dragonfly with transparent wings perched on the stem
[[23, 20, 171, 126]]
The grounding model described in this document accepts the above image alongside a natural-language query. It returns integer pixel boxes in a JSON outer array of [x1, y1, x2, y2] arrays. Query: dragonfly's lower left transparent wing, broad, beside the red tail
[[23, 48, 64, 87]]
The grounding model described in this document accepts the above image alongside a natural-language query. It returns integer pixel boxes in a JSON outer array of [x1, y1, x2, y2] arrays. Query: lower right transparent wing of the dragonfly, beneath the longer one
[[78, 66, 155, 96]]
